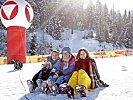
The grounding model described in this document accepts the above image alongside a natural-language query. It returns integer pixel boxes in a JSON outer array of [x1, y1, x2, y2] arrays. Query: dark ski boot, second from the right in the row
[[59, 83, 74, 98]]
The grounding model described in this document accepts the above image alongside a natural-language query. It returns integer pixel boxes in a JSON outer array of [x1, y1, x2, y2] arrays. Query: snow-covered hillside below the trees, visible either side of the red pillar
[[0, 28, 126, 55]]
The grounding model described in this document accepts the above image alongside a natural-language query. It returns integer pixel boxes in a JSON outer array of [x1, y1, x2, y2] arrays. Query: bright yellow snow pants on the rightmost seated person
[[68, 69, 91, 90]]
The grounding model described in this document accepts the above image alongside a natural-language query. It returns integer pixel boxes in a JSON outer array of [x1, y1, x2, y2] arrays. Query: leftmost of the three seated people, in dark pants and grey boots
[[27, 50, 59, 92]]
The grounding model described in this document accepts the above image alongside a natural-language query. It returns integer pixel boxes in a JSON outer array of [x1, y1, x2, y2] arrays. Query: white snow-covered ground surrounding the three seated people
[[0, 56, 133, 100]]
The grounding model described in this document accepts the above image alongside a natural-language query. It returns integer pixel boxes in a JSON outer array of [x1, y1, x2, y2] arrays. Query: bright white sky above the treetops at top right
[[92, 0, 133, 12]]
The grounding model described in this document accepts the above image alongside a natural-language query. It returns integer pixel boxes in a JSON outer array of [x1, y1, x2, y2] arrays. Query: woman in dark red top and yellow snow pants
[[68, 49, 95, 96]]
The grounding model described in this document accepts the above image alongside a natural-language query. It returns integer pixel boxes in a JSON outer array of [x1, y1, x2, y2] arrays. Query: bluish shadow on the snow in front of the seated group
[[19, 87, 105, 100]]
